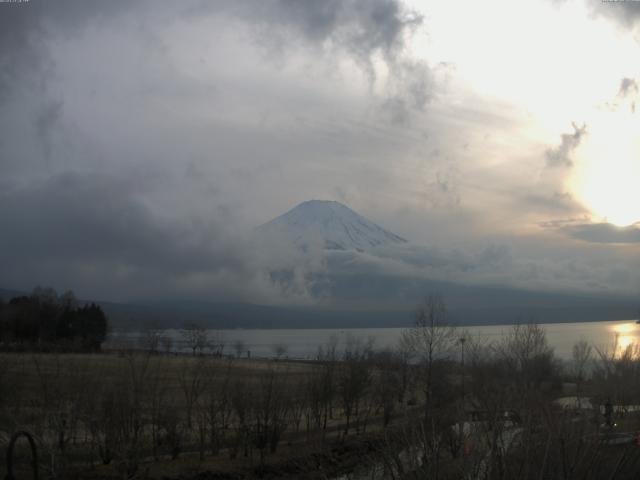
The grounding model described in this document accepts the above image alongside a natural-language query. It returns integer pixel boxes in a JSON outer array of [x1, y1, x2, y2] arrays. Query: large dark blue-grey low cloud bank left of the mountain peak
[[0, 173, 260, 293]]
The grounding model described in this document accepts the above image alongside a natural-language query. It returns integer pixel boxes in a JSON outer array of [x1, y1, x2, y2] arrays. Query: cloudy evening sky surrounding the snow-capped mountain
[[0, 0, 640, 303]]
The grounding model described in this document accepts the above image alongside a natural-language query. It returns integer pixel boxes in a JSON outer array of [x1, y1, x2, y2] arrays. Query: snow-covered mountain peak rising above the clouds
[[256, 200, 407, 251]]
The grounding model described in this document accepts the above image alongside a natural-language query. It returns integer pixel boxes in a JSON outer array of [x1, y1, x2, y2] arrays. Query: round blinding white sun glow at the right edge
[[570, 109, 640, 226]]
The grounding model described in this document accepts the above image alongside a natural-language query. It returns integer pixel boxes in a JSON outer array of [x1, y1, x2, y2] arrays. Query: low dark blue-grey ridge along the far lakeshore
[[0, 283, 637, 331]]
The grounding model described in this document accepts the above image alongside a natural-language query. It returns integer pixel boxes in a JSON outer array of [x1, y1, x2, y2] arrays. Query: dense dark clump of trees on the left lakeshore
[[0, 287, 109, 351]]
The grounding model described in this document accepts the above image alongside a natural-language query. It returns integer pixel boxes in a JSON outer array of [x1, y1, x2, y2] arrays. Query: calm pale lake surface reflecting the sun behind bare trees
[[112, 320, 640, 360]]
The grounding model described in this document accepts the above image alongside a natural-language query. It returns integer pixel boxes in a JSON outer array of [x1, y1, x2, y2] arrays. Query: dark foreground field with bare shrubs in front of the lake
[[5, 325, 640, 480]]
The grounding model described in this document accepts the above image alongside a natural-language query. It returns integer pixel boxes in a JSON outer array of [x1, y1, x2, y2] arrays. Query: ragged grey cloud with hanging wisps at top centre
[[202, 0, 435, 124]]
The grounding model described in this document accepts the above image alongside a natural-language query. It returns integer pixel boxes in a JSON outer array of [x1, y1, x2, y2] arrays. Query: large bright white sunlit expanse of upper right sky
[[410, 0, 640, 226]]
